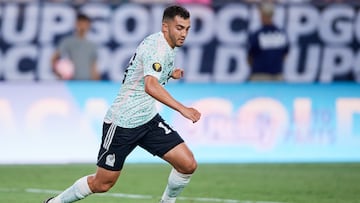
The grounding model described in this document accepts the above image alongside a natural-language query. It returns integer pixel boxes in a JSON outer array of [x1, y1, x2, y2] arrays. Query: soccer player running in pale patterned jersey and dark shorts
[[45, 5, 200, 203]]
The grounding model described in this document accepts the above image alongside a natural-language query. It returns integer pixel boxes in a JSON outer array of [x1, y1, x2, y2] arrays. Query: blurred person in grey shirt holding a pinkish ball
[[51, 14, 100, 80]]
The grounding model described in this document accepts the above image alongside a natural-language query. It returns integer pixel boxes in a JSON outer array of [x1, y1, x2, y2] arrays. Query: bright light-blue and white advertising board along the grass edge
[[0, 82, 360, 164]]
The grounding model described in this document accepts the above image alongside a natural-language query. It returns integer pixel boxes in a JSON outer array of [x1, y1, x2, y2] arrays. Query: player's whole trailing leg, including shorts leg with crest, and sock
[[47, 123, 136, 203]]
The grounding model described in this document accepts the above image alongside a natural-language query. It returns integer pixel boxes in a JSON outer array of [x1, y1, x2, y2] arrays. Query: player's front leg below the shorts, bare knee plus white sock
[[161, 143, 197, 203]]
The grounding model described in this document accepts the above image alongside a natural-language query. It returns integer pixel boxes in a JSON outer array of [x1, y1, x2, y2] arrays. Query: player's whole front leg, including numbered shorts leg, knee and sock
[[139, 115, 197, 203]]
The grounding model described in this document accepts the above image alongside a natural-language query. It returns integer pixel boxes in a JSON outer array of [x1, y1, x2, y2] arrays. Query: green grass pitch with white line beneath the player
[[0, 163, 360, 203]]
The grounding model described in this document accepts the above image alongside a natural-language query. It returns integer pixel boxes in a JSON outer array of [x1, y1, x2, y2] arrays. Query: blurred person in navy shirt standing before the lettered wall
[[248, 2, 289, 80]]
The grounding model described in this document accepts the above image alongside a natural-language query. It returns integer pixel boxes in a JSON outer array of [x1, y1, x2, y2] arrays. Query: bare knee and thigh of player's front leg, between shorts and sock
[[161, 142, 197, 174]]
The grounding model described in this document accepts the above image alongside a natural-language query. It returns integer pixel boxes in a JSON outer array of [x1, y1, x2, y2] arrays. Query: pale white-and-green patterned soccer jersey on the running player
[[104, 32, 176, 128]]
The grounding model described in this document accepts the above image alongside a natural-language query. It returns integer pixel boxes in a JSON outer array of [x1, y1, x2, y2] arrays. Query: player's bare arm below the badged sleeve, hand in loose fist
[[145, 75, 201, 123]]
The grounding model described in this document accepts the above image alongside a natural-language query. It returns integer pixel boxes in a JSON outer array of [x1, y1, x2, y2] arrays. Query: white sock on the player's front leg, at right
[[161, 169, 192, 203]]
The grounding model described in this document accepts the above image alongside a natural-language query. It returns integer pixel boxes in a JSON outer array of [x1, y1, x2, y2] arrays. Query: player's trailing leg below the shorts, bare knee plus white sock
[[47, 167, 120, 203]]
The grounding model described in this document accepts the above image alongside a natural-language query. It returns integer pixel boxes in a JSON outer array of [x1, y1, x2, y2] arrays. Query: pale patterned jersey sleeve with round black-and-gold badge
[[142, 38, 166, 79]]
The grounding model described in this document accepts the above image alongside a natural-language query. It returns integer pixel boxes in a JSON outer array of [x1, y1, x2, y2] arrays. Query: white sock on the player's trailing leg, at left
[[50, 176, 93, 203]]
